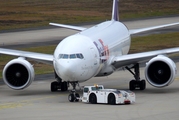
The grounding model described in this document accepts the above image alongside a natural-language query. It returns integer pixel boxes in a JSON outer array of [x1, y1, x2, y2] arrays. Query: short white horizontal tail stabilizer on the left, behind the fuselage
[[49, 23, 86, 31]]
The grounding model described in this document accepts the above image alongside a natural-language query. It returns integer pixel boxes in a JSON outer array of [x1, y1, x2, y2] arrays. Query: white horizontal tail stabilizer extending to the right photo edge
[[129, 22, 179, 35]]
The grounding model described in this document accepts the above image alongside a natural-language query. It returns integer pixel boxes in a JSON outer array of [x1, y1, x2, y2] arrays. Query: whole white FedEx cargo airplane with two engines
[[0, 0, 179, 100]]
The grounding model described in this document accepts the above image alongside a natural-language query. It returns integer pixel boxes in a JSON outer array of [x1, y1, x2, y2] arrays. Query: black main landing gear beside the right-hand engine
[[125, 63, 146, 90]]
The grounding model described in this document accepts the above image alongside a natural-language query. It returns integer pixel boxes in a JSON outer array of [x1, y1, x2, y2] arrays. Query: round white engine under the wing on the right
[[145, 55, 177, 87]]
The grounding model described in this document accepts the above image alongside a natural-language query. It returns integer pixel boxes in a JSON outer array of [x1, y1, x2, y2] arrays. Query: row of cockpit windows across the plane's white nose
[[59, 53, 84, 59]]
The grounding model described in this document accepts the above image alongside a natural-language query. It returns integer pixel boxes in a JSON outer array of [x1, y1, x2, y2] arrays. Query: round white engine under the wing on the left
[[3, 57, 35, 90]]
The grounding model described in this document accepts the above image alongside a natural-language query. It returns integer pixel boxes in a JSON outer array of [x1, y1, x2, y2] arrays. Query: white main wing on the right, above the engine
[[112, 47, 179, 68]]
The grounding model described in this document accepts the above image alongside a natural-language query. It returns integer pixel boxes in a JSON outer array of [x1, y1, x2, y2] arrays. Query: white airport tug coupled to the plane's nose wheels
[[68, 85, 135, 105]]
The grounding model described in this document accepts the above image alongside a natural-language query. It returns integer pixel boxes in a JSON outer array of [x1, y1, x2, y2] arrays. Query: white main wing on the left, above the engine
[[0, 48, 53, 64]]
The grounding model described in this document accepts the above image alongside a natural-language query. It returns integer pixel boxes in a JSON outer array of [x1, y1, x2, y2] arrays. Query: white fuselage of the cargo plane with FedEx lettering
[[53, 21, 131, 82]]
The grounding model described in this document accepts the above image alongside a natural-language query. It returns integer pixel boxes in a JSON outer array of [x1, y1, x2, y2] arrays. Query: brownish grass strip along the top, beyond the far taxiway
[[0, 0, 179, 30]]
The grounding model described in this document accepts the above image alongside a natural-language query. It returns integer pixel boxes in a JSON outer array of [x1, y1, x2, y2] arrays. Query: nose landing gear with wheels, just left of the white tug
[[68, 82, 80, 102]]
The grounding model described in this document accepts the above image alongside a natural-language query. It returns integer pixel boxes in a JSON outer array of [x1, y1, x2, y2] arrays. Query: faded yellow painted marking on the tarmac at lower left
[[0, 95, 60, 110]]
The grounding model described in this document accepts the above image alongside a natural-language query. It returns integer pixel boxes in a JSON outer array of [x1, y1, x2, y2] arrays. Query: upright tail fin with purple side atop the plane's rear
[[111, 0, 119, 21]]
